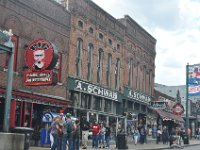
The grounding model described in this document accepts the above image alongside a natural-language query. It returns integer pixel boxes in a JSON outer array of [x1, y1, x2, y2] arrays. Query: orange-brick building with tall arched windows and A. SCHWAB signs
[[65, 0, 156, 131]]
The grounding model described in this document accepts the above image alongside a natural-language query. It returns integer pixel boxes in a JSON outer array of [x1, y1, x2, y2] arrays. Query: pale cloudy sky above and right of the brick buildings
[[93, 0, 200, 86]]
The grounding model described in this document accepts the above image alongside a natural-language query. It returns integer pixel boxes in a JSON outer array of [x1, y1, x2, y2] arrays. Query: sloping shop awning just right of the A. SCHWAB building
[[156, 110, 184, 122]]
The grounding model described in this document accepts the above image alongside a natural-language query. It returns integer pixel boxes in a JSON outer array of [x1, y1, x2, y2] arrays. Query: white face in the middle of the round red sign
[[33, 50, 45, 70]]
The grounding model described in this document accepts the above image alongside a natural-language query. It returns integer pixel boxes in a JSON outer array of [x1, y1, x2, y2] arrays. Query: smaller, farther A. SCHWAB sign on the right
[[124, 87, 151, 104]]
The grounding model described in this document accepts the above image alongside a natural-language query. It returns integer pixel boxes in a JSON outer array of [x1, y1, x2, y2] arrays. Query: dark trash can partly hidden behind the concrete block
[[11, 127, 33, 150]]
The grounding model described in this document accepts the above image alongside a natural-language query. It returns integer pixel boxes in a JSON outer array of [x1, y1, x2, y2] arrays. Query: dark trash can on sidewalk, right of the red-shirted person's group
[[117, 133, 128, 149]]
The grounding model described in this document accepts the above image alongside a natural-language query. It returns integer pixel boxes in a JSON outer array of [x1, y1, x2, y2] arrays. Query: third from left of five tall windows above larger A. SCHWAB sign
[[97, 48, 103, 83]]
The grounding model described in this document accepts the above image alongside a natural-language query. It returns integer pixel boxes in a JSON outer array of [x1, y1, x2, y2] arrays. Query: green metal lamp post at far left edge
[[0, 30, 14, 132]]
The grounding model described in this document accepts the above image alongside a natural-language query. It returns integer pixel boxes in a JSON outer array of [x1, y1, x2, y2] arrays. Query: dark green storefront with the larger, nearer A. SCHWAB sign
[[67, 77, 126, 135]]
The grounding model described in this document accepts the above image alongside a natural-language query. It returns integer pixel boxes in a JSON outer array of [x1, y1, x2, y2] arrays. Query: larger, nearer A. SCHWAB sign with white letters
[[68, 77, 119, 101]]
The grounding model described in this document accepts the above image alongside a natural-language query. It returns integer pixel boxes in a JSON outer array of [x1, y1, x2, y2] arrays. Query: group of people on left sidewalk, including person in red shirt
[[50, 113, 111, 150]]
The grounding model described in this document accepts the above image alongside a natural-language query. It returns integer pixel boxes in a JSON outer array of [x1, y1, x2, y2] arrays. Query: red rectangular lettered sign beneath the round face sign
[[24, 70, 53, 85]]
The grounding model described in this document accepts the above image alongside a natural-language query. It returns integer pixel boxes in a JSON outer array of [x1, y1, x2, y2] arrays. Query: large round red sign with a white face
[[25, 40, 58, 71]]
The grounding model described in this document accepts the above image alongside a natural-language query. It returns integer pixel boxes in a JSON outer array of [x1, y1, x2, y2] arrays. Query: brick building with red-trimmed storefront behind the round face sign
[[0, 0, 70, 127]]
